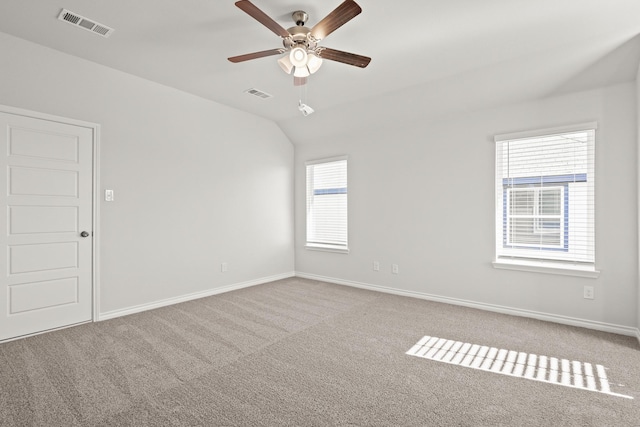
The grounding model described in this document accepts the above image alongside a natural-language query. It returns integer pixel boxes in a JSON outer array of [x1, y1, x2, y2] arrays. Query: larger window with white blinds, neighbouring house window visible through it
[[495, 123, 597, 270]]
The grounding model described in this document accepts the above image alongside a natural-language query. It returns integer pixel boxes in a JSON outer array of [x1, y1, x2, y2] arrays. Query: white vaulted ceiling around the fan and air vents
[[0, 0, 640, 143]]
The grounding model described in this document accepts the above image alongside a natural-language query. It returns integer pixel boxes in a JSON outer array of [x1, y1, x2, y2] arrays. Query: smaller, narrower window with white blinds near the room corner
[[306, 157, 348, 252]]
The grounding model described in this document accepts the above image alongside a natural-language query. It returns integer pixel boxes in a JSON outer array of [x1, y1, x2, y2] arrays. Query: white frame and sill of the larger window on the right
[[492, 122, 600, 278]]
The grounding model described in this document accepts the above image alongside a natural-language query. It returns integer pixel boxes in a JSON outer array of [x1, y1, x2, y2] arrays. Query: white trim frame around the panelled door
[[0, 104, 100, 328]]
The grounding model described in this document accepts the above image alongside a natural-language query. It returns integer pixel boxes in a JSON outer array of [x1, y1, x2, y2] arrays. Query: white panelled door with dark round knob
[[0, 112, 93, 341]]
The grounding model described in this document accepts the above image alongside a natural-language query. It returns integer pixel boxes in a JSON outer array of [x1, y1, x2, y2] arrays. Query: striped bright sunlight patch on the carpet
[[406, 336, 633, 399]]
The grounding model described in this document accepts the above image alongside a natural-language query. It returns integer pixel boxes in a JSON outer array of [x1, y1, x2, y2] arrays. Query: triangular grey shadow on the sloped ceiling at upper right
[[550, 34, 640, 95]]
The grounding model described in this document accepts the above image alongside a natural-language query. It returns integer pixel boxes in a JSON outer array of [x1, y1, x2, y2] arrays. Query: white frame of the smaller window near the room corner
[[305, 155, 349, 254]]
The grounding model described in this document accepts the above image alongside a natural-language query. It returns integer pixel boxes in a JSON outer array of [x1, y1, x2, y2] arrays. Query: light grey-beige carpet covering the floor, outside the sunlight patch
[[0, 278, 640, 426]]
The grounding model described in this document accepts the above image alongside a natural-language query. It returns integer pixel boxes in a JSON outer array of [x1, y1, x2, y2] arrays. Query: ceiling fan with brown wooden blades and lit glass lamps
[[228, 0, 371, 86]]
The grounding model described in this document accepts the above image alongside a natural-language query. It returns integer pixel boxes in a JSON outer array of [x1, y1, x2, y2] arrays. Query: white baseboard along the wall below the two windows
[[296, 271, 640, 341]]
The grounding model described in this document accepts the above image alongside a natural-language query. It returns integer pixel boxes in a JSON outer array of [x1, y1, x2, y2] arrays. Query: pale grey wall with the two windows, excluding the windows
[[295, 83, 638, 333]]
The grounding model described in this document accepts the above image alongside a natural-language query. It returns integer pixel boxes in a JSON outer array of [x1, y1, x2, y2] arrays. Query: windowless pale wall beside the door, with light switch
[[0, 33, 294, 313]]
